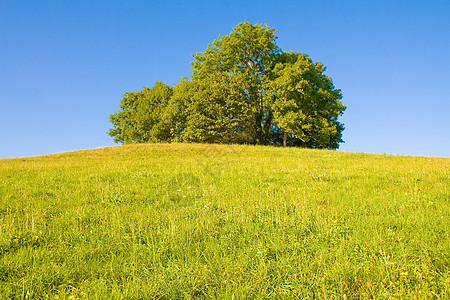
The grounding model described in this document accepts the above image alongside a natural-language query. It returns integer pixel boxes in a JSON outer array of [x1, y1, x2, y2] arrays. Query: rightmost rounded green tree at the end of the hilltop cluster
[[268, 52, 345, 149]]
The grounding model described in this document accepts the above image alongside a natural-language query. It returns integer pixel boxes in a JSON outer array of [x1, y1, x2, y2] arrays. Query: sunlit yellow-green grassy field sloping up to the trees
[[0, 144, 450, 299]]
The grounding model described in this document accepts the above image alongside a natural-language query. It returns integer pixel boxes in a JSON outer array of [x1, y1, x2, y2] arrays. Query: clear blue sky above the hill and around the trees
[[0, 0, 450, 157]]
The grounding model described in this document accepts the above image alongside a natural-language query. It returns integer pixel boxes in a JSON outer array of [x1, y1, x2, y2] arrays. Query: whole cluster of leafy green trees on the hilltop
[[109, 22, 345, 149]]
